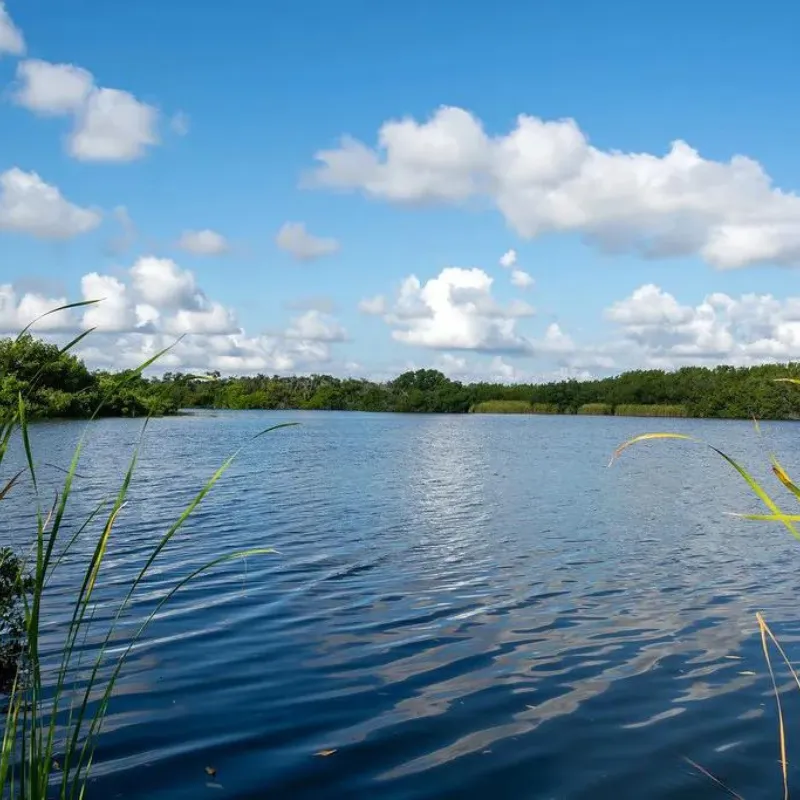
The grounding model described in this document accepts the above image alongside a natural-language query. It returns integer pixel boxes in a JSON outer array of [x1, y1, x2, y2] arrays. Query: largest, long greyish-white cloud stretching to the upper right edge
[[306, 107, 800, 269]]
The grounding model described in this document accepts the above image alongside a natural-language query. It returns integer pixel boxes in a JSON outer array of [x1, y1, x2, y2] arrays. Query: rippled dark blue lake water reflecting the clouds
[[4, 412, 800, 800]]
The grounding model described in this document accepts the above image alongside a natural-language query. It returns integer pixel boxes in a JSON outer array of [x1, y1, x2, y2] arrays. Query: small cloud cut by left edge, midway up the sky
[[0, 167, 100, 239]]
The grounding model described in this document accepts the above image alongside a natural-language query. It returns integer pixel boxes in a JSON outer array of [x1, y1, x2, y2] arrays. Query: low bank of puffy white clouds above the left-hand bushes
[[0, 256, 346, 373]]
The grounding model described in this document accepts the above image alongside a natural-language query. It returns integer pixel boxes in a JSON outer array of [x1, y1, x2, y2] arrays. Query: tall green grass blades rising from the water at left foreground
[[0, 303, 294, 800]]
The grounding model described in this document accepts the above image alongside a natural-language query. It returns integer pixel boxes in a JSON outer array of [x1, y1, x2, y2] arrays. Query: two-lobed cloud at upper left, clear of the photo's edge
[[13, 59, 159, 161]]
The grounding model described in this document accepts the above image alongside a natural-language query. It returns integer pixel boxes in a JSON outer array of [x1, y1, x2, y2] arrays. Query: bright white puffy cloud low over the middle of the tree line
[[378, 267, 533, 352]]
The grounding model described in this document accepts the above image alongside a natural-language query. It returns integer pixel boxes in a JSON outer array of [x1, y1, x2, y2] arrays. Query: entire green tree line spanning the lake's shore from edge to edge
[[0, 335, 800, 419]]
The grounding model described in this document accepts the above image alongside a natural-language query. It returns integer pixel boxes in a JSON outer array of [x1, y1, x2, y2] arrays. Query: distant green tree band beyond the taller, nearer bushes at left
[[148, 364, 800, 419]]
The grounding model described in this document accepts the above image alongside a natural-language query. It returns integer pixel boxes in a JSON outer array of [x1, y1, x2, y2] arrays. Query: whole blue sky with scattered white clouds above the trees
[[0, 0, 800, 382]]
